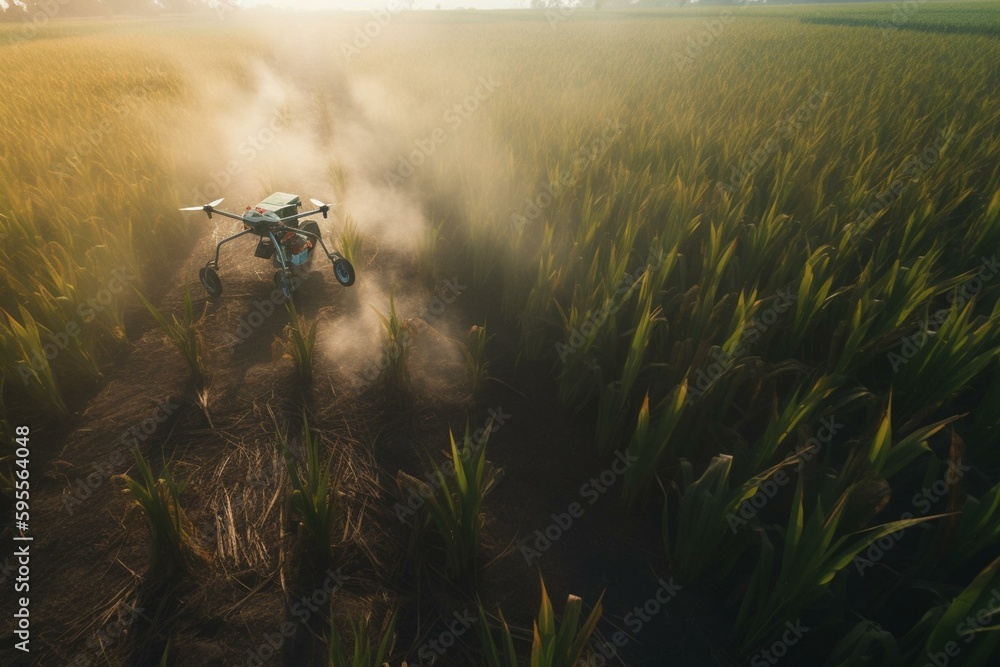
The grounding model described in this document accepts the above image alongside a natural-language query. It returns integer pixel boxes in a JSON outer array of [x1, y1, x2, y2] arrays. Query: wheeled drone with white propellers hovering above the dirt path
[[180, 192, 354, 299]]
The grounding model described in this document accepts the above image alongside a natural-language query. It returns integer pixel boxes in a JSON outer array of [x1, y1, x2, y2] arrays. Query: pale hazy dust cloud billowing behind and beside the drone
[[159, 19, 476, 388]]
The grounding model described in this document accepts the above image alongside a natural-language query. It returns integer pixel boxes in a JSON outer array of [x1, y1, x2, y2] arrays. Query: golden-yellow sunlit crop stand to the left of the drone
[[0, 48, 182, 434]]
